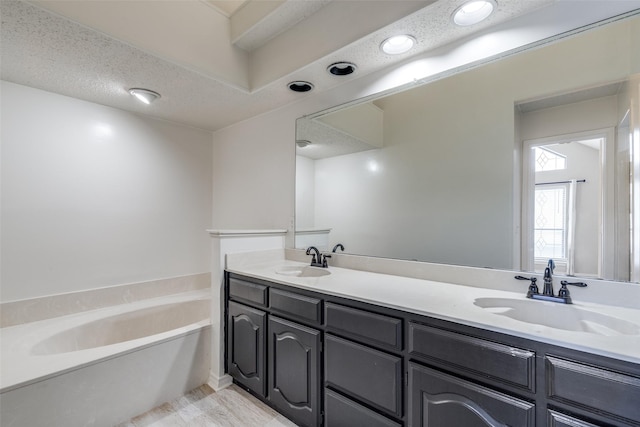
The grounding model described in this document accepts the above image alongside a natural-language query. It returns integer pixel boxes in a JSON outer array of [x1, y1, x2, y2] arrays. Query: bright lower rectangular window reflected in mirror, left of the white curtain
[[533, 184, 569, 260]]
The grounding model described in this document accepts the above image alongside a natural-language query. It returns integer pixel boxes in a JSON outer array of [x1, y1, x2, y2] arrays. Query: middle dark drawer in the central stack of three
[[325, 334, 402, 418]]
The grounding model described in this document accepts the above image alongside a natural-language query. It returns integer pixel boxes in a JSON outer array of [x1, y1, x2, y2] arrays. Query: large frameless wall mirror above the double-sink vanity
[[296, 11, 640, 282]]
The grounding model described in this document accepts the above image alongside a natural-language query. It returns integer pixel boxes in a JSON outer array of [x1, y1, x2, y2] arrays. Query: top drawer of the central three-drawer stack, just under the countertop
[[325, 302, 402, 351]]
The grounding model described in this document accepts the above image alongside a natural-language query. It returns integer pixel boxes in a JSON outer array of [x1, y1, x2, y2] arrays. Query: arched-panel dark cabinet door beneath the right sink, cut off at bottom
[[409, 363, 535, 427]]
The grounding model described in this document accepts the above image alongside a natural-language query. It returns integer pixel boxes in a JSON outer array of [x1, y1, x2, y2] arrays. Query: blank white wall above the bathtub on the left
[[1, 82, 212, 301]]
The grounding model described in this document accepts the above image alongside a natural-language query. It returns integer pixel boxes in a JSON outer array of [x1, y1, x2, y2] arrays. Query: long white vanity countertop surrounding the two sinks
[[227, 254, 640, 363]]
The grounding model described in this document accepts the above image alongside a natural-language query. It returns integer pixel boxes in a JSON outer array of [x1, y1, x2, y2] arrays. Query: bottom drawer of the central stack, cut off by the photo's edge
[[324, 389, 401, 427]]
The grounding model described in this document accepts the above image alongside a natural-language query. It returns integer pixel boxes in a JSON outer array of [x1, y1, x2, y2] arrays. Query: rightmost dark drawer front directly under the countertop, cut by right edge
[[545, 356, 640, 425]]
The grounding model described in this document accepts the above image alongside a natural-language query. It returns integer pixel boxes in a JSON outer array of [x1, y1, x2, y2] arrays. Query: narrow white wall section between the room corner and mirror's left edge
[[213, 108, 295, 229]]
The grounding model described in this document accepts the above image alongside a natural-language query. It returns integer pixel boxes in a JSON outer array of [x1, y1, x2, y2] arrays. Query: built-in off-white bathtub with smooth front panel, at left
[[0, 289, 211, 427]]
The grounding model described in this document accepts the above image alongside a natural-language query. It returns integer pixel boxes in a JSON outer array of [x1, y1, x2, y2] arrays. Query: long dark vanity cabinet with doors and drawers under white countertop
[[226, 273, 640, 427]]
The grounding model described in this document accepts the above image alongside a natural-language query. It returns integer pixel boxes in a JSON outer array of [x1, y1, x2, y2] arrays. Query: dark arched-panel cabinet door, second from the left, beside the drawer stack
[[269, 316, 321, 426]]
